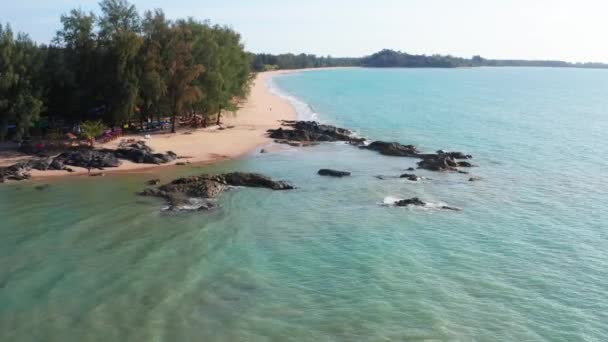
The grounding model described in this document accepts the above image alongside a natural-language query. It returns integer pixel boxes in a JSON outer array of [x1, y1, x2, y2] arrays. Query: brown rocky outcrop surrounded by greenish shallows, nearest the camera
[[140, 172, 294, 210]]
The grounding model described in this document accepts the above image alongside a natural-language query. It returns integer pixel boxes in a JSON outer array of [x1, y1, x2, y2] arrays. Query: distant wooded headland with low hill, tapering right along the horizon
[[359, 50, 608, 68]]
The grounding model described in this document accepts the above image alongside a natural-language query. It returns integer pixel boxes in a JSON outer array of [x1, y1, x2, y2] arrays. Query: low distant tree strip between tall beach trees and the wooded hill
[[252, 53, 361, 71]]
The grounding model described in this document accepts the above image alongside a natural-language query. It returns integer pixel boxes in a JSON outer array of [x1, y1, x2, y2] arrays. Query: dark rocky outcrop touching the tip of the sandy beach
[[268, 121, 365, 145]]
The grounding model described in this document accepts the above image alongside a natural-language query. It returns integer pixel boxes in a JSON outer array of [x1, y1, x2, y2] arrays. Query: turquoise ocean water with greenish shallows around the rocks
[[0, 68, 608, 342]]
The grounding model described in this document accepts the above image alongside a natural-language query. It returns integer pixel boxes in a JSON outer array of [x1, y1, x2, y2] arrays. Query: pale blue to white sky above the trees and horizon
[[0, 0, 608, 62]]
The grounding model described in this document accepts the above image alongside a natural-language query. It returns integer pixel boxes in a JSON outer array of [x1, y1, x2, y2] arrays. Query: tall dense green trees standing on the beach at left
[[0, 0, 252, 139]]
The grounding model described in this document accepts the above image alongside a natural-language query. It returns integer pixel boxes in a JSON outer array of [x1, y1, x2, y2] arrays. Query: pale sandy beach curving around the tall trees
[[0, 70, 301, 178]]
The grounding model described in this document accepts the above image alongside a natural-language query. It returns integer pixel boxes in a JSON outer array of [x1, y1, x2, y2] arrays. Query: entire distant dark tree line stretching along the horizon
[[252, 50, 608, 71]]
